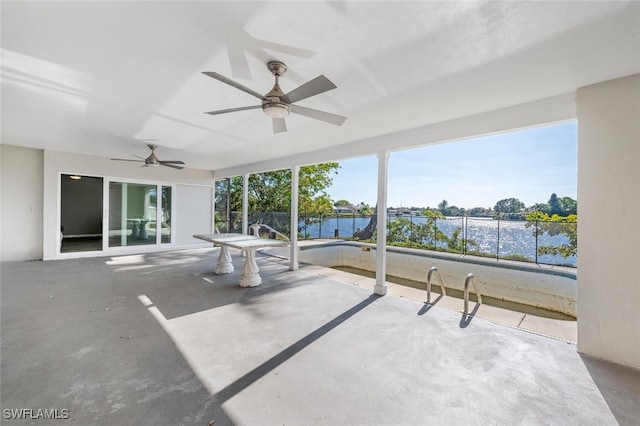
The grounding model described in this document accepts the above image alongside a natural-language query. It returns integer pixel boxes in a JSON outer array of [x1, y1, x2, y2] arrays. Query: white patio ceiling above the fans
[[1, 1, 640, 170]]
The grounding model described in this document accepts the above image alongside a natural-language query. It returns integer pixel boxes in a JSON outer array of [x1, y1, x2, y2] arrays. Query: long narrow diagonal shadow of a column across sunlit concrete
[[215, 294, 382, 404]]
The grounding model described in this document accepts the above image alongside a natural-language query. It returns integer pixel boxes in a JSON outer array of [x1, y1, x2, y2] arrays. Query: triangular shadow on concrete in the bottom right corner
[[580, 354, 640, 426]]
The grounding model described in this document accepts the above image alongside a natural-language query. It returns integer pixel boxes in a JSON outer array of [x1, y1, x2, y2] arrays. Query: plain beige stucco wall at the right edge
[[577, 75, 640, 368]]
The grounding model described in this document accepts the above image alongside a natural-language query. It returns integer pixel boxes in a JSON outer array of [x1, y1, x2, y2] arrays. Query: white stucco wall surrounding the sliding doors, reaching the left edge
[[0, 145, 218, 260]]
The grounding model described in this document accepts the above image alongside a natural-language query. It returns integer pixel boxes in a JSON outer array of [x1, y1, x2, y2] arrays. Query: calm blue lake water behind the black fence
[[300, 216, 577, 266]]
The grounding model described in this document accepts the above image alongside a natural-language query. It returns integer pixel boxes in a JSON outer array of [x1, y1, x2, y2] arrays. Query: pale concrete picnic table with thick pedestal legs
[[193, 233, 289, 287]]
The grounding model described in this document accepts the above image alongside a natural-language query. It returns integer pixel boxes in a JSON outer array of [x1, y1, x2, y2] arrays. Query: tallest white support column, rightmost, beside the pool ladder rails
[[373, 151, 389, 296]]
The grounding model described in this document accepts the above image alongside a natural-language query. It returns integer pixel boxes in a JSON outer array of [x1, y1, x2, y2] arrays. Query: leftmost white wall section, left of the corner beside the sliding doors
[[0, 145, 44, 260]]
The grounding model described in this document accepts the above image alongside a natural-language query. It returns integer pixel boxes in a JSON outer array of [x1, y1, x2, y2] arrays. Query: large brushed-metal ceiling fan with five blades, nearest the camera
[[203, 61, 347, 133]]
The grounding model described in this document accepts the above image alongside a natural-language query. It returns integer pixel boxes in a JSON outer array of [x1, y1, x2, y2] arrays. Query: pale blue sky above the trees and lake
[[328, 121, 578, 209]]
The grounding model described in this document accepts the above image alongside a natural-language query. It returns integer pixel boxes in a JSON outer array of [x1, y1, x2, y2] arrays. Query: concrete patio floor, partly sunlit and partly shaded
[[1, 249, 640, 425]]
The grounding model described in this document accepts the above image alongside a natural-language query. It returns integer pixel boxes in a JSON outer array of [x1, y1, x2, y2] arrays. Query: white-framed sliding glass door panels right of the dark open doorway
[[108, 181, 172, 247]]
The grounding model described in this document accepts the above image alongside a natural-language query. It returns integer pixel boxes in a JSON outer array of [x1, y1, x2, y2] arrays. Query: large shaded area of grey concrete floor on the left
[[0, 256, 237, 426]]
